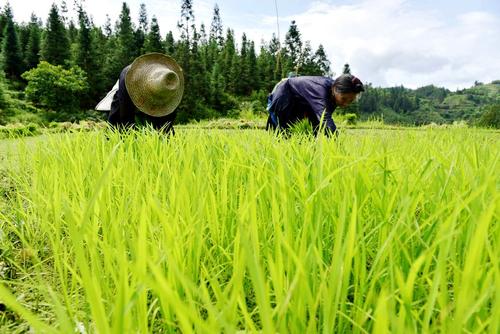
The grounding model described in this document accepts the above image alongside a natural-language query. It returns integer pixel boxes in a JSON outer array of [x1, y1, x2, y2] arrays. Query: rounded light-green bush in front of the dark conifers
[[23, 61, 88, 112]]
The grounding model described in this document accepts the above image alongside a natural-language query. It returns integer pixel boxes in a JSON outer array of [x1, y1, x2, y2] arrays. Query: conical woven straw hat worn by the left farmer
[[125, 53, 184, 117]]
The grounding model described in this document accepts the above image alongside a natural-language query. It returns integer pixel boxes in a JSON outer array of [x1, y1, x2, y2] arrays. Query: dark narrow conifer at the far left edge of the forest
[[0, 4, 23, 80]]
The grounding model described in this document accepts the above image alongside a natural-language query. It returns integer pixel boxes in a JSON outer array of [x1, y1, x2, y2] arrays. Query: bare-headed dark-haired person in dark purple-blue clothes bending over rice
[[266, 74, 364, 135]]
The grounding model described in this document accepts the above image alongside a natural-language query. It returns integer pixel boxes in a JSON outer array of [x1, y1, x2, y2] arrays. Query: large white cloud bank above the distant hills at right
[[274, 0, 500, 89]]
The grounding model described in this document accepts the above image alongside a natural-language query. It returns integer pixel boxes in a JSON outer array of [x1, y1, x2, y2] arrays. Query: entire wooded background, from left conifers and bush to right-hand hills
[[0, 0, 500, 128]]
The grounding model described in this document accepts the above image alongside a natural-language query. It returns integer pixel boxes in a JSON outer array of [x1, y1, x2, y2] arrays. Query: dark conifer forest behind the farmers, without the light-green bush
[[0, 0, 330, 121]]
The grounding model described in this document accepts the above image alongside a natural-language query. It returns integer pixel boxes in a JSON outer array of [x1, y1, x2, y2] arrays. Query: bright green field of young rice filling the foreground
[[0, 129, 500, 333]]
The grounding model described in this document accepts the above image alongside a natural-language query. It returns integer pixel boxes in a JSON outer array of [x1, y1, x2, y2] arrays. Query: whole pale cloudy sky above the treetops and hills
[[0, 0, 500, 90]]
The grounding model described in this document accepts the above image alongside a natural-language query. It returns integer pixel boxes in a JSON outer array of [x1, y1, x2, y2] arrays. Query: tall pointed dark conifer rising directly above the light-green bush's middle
[[41, 4, 70, 65]]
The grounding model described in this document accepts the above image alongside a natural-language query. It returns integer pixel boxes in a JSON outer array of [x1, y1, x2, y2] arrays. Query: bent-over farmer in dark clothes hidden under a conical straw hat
[[96, 53, 184, 134]]
